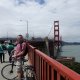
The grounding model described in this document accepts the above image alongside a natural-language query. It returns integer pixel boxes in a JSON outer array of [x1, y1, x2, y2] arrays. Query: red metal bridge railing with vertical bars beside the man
[[28, 45, 80, 80]]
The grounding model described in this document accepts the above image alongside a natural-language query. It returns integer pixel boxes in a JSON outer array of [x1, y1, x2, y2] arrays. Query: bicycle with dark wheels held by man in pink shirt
[[1, 50, 37, 80]]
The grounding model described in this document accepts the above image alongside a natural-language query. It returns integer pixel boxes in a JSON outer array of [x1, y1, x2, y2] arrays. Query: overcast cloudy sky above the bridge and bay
[[0, 0, 80, 41]]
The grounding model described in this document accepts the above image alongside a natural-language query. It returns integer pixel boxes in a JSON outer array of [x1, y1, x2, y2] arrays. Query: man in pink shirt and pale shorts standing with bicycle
[[12, 35, 26, 80]]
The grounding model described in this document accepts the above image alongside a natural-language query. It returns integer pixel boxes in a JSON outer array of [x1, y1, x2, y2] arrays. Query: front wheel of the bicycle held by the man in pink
[[1, 64, 17, 80]]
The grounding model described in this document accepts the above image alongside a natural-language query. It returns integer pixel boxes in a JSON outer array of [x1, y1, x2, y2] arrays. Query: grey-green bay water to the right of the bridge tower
[[61, 45, 80, 62]]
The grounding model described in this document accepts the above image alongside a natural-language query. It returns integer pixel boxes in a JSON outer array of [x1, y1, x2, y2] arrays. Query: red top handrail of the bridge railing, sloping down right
[[29, 45, 80, 80]]
